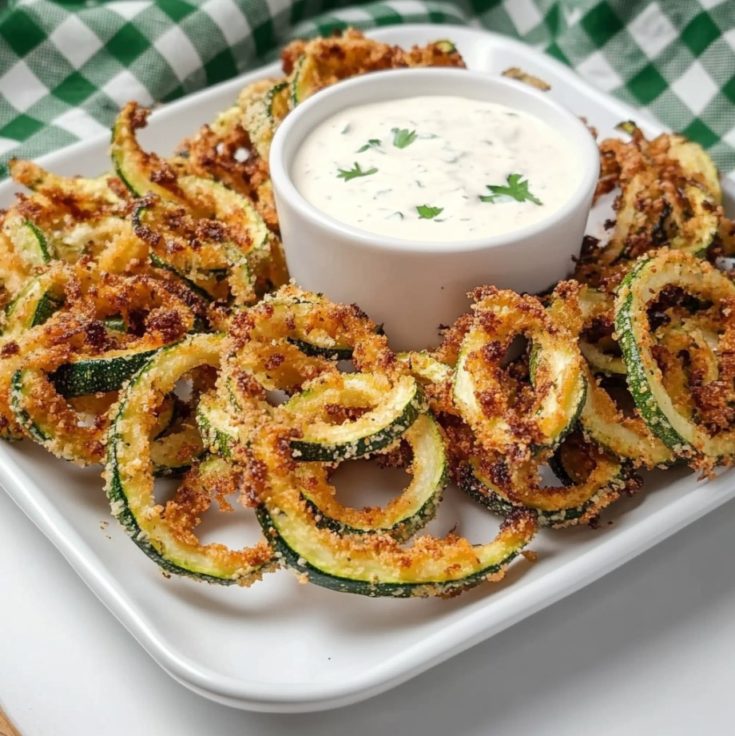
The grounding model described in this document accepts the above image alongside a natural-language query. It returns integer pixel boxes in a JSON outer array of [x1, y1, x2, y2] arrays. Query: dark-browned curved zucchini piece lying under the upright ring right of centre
[[457, 435, 636, 528]]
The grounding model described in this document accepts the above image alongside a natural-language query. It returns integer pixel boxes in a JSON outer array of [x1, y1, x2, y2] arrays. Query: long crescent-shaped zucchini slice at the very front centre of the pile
[[254, 431, 536, 598]]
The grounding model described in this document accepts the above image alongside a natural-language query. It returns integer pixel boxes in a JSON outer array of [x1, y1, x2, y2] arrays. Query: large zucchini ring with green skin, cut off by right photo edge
[[615, 250, 735, 462]]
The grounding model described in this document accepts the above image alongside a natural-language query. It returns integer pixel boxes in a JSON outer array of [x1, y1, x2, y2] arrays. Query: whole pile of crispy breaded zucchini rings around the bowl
[[0, 31, 735, 597]]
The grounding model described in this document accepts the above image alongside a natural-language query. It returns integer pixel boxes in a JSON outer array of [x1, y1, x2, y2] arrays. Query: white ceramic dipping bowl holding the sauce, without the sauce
[[270, 69, 599, 350]]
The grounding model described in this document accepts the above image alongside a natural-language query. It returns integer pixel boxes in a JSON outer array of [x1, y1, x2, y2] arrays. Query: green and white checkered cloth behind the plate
[[0, 0, 735, 177]]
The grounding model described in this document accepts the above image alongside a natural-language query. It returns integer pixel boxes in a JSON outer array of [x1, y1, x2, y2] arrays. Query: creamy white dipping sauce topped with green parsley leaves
[[291, 95, 582, 242]]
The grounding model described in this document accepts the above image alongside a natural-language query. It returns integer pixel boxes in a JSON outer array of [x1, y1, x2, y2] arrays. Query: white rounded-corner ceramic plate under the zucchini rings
[[0, 26, 735, 712]]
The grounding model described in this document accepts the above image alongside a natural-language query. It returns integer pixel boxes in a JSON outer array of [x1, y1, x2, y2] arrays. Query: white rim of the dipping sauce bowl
[[269, 67, 600, 255]]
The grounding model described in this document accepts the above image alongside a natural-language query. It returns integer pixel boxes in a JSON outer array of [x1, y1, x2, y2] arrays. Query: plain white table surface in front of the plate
[[0, 480, 735, 736]]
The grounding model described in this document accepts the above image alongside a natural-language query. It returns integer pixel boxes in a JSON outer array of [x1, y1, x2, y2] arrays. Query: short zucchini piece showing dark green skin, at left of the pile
[[50, 348, 158, 398]]
